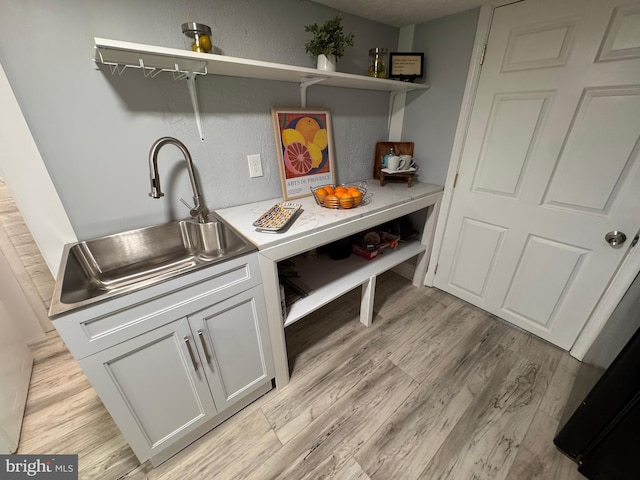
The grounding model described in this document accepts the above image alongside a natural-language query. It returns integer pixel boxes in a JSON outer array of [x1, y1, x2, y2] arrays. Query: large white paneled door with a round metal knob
[[435, 0, 640, 349]]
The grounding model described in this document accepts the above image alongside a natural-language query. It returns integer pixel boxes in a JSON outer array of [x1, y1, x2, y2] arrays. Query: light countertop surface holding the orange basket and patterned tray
[[216, 179, 443, 250]]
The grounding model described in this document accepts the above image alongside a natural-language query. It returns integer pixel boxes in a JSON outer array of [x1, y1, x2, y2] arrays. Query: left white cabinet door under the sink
[[80, 318, 217, 461]]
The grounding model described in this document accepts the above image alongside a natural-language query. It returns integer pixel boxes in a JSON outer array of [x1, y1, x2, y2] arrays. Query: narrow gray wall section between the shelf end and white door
[[402, 9, 480, 185]]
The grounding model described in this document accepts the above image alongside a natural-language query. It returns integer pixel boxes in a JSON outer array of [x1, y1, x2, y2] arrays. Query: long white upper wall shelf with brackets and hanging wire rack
[[95, 38, 429, 140]]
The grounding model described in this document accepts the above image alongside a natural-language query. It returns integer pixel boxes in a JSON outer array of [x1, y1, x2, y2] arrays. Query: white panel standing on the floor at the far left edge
[[0, 299, 33, 454]]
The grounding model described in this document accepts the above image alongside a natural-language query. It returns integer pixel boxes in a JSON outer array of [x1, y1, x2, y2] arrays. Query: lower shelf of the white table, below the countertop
[[284, 240, 425, 327]]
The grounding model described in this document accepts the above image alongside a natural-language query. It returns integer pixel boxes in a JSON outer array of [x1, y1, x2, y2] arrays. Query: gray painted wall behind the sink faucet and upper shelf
[[0, 0, 398, 239]]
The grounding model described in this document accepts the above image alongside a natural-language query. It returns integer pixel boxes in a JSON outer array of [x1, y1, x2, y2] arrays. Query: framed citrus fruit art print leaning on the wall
[[271, 107, 335, 200]]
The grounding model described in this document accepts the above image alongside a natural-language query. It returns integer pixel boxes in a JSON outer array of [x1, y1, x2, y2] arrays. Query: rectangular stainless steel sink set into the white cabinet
[[49, 214, 255, 316]]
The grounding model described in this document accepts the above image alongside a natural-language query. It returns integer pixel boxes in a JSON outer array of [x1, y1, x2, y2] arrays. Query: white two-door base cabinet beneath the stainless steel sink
[[54, 253, 274, 465]]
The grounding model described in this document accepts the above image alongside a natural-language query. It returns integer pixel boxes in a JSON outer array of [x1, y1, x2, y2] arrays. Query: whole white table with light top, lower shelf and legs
[[216, 179, 443, 388]]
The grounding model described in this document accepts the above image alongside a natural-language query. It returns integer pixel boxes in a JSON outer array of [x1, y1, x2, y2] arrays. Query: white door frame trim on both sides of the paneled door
[[425, 0, 640, 360]]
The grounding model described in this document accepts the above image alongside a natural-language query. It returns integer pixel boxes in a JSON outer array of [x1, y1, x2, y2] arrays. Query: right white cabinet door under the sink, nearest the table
[[189, 286, 273, 411]]
